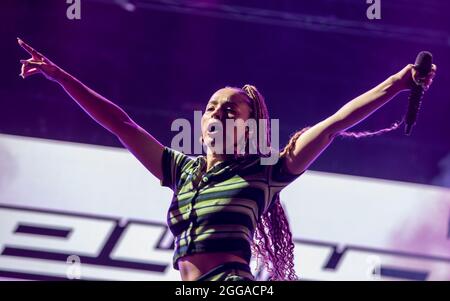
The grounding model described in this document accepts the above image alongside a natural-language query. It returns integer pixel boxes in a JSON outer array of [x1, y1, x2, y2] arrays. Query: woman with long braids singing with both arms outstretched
[[18, 39, 436, 280]]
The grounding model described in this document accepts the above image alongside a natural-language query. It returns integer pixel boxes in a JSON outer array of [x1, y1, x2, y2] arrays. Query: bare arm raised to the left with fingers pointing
[[18, 39, 164, 180]]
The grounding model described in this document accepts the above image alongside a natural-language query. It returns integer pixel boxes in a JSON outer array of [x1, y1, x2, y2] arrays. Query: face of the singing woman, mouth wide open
[[201, 88, 251, 153]]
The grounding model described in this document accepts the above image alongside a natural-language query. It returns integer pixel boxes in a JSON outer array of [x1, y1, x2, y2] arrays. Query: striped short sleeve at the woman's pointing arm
[[161, 146, 193, 191]]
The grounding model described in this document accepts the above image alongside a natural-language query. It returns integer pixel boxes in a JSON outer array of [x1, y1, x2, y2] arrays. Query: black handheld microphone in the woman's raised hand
[[405, 51, 433, 136]]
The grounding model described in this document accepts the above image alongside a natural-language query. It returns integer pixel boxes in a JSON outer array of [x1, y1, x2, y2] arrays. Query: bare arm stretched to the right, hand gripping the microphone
[[284, 64, 436, 174]]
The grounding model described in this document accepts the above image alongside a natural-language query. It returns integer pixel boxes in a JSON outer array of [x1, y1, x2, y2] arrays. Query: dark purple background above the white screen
[[0, 0, 450, 187]]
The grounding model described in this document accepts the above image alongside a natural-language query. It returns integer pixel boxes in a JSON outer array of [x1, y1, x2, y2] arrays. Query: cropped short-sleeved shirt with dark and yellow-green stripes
[[161, 147, 302, 270]]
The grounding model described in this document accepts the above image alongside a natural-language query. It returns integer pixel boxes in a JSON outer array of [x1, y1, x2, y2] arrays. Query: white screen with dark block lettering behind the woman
[[0, 135, 450, 280]]
